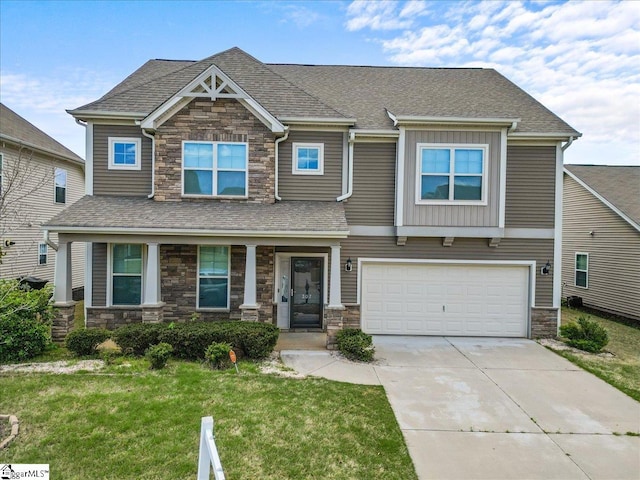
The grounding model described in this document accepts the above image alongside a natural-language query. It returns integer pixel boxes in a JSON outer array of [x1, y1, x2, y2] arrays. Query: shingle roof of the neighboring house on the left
[[0, 103, 84, 163]]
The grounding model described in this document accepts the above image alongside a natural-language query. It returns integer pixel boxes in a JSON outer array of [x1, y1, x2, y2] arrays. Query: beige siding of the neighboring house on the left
[[0, 145, 85, 288]]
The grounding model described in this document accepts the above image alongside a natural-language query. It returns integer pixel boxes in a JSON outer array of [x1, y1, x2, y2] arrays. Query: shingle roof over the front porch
[[43, 196, 348, 237]]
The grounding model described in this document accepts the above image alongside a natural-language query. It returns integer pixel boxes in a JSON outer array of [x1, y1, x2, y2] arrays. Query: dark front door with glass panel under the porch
[[289, 257, 324, 328]]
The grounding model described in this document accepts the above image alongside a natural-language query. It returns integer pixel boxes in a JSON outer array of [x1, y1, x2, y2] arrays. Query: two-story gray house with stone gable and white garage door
[[46, 48, 580, 345]]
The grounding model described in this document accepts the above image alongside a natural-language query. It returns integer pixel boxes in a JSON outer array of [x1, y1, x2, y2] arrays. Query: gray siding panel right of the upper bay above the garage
[[505, 146, 556, 228]]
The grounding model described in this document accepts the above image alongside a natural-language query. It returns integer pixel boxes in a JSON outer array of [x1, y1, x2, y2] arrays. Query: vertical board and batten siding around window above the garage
[[403, 130, 501, 227]]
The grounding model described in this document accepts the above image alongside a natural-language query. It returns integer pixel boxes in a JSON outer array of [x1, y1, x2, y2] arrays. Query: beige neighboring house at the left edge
[[0, 103, 85, 294]]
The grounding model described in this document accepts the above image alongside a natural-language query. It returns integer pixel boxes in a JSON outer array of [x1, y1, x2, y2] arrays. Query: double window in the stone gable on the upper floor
[[182, 142, 249, 197]]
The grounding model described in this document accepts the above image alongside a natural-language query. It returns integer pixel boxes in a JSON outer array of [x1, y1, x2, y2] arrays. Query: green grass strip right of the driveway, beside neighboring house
[[557, 307, 640, 401]]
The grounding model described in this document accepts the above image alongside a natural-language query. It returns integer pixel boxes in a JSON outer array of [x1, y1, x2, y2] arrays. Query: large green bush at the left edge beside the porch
[[0, 280, 54, 362]]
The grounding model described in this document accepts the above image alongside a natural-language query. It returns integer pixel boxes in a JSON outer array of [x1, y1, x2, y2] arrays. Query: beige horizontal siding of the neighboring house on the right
[[562, 174, 640, 320]]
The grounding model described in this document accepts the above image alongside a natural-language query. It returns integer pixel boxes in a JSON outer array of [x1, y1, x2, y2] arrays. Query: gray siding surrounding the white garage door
[[340, 236, 553, 307]]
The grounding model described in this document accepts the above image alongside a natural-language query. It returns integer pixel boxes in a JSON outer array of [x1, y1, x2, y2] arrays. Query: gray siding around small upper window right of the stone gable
[[278, 131, 346, 201]]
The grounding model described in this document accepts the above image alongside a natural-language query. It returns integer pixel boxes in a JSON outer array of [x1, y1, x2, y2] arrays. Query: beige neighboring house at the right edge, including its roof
[[562, 165, 640, 320]]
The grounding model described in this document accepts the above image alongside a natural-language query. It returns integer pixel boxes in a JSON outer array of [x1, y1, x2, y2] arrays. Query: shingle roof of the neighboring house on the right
[[564, 165, 640, 225]]
